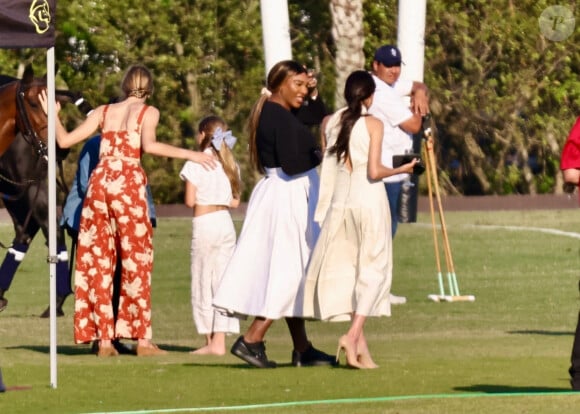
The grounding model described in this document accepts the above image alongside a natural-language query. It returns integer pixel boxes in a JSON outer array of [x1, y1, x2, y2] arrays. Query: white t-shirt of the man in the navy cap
[[369, 75, 413, 182]]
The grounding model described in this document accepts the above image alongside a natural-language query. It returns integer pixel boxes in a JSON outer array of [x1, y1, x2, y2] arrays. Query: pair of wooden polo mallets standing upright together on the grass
[[423, 117, 475, 302]]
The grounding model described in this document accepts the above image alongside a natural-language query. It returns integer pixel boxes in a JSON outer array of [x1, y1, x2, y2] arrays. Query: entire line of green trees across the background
[[0, 0, 580, 203]]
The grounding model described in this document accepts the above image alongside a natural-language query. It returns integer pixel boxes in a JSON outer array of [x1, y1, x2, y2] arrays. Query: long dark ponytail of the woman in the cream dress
[[328, 70, 376, 161]]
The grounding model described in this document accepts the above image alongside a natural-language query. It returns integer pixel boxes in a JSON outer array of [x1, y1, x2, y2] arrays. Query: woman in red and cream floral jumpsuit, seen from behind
[[40, 65, 215, 357]]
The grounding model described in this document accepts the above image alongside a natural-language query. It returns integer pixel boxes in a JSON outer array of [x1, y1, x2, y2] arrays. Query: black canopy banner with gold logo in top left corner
[[0, 0, 56, 49]]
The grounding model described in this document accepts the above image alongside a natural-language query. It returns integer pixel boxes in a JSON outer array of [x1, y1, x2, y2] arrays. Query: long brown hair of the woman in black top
[[248, 60, 307, 174]]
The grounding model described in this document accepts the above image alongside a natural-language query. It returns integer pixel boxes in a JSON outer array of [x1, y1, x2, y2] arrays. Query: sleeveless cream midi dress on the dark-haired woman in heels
[[304, 111, 392, 321]]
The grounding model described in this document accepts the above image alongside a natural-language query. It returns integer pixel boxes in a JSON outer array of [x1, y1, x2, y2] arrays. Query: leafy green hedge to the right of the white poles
[[425, 0, 580, 194]]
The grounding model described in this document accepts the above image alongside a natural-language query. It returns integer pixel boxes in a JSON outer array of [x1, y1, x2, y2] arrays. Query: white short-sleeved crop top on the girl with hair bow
[[179, 148, 233, 206]]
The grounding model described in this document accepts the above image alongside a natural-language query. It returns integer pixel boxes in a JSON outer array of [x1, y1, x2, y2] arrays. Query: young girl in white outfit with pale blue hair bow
[[180, 116, 241, 355]]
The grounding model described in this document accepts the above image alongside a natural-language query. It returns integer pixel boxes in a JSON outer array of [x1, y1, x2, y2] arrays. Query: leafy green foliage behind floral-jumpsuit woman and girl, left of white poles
[[52, 0, 263, 202]]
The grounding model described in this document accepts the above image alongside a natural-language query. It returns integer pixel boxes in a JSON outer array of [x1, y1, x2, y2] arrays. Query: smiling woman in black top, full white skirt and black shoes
[[213, 60, 335, 368]]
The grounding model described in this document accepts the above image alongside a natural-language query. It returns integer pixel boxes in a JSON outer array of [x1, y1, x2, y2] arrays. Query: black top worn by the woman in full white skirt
[[256, 101, 320, 175]]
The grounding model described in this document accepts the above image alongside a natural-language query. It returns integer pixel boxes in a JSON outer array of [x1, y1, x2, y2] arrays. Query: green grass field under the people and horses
[[0, 210, 580, 414]]
